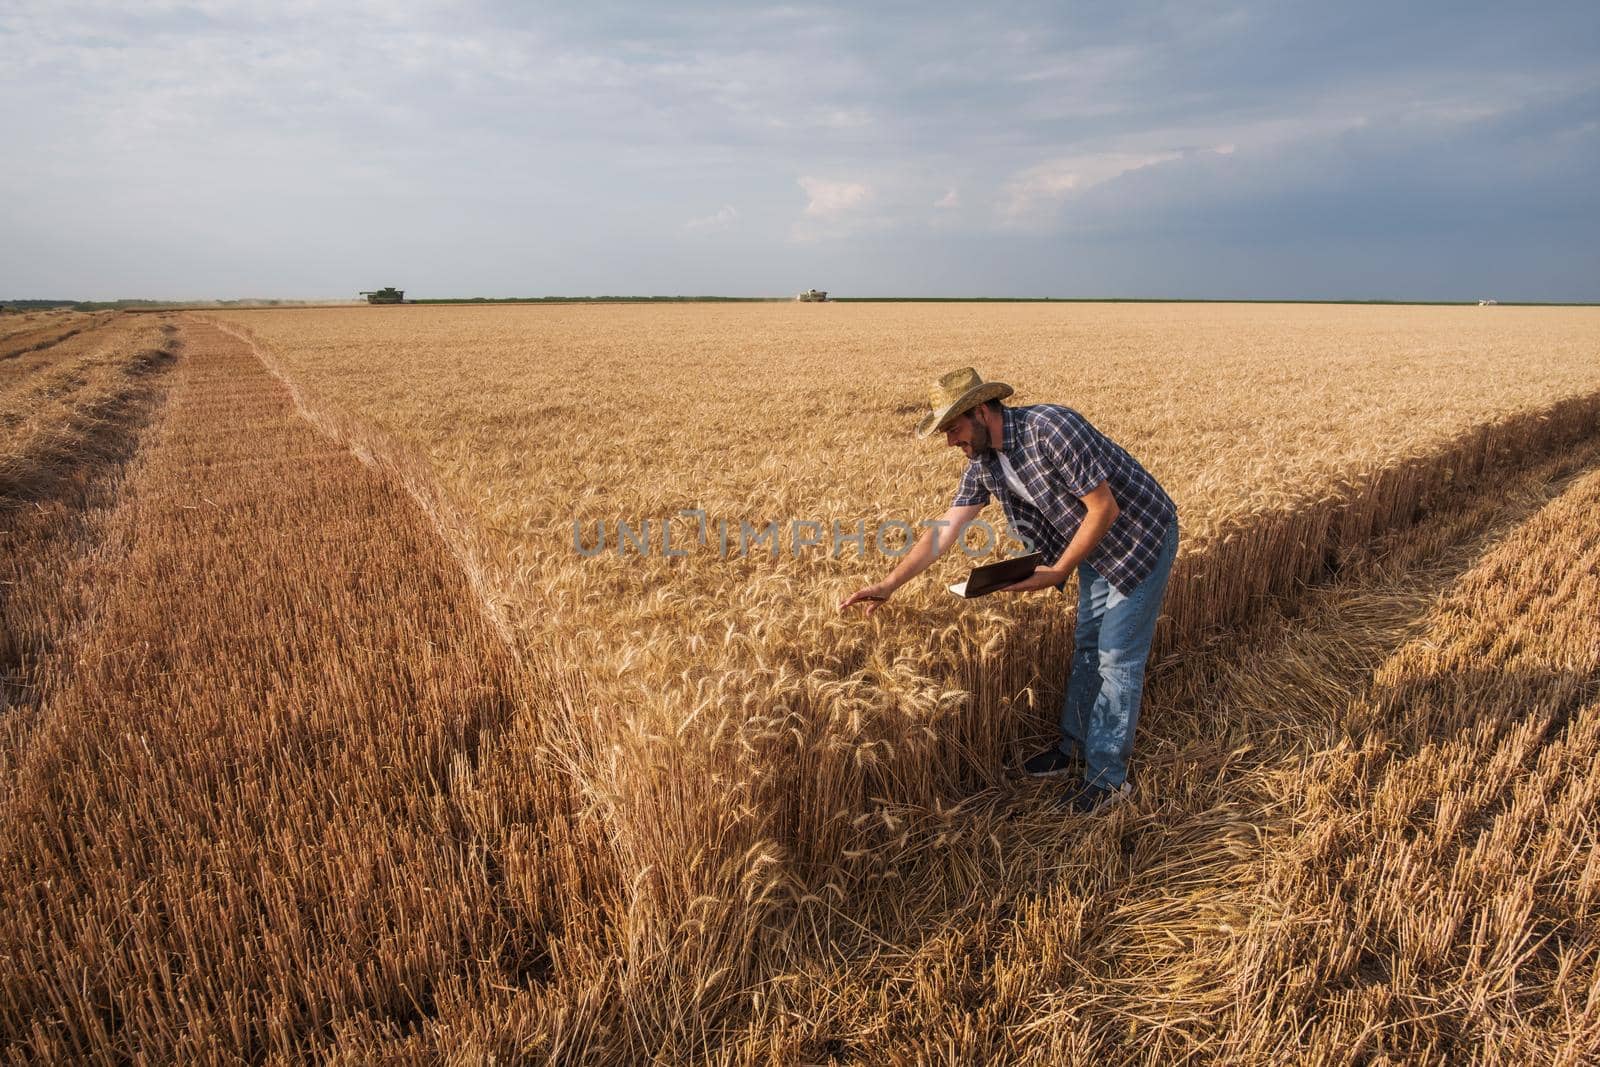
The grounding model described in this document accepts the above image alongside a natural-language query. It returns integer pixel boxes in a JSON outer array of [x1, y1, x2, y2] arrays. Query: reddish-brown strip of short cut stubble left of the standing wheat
[[0, 326, 588, 1062]]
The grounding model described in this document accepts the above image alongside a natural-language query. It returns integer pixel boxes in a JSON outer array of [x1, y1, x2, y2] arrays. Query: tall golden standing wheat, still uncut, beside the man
[[190, 306, 1600, 1051]]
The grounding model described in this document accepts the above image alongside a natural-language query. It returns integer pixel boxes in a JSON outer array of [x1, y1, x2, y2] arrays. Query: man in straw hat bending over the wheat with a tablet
[[838, 366, 1178, 813]]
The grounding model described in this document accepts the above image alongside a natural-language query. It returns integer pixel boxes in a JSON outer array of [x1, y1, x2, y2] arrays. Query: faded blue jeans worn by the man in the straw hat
[[1061, 520, 1178, 789]]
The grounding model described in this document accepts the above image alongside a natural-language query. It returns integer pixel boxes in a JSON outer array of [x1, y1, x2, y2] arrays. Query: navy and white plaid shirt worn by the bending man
[[950, 403, 1178, 595]]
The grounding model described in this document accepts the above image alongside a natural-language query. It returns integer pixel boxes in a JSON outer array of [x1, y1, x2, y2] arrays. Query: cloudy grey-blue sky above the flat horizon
[[0, 0, 1600, 301]]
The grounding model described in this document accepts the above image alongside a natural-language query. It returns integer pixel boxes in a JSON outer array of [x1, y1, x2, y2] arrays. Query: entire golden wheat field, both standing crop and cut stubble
[[0, 304, 1600, 1064]]
